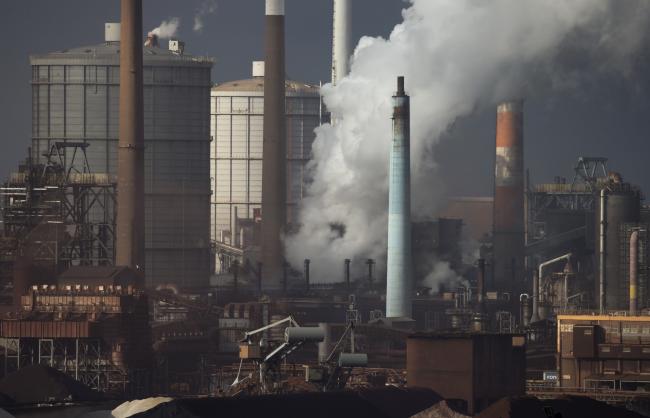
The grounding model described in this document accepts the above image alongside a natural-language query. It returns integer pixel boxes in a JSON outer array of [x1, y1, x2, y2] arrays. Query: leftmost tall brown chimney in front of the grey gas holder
[[115, 0, 145, 282]]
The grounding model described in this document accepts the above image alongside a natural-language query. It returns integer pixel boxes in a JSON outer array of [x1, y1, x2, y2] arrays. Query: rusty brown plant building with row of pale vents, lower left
[[0, 266, 153, 393]]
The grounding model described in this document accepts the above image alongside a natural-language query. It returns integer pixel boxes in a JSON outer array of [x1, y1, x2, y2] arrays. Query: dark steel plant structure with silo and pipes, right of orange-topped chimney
[[526, 157, 650, 319]]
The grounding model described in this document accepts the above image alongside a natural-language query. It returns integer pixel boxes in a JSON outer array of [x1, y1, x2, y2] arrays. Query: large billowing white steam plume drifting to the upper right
[[285, 0, 650, 281]]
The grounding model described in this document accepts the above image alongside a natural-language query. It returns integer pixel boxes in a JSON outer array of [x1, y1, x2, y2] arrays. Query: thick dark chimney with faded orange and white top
[[492, 101, 525, 300]]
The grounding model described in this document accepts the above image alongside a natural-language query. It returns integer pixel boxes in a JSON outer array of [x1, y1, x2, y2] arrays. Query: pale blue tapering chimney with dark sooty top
[[386, 77, 413, 318]]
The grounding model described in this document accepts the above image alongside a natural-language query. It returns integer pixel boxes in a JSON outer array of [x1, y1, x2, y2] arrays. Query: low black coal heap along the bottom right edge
[[477, 396, 643, 418]]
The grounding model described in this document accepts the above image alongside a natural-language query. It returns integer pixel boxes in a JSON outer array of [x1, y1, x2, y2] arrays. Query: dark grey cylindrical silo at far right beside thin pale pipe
[[595, 188, 641, 310]]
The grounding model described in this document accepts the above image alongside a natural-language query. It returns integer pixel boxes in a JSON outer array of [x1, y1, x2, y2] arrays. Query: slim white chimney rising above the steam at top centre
[[332, 0, 352, 84]]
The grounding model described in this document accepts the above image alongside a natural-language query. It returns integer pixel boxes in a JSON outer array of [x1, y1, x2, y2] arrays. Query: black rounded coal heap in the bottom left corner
[[0, 365, 102, 404]]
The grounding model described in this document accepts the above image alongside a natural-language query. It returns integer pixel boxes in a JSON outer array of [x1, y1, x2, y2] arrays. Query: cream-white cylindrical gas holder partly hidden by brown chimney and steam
[[210, 62, 323, 272]]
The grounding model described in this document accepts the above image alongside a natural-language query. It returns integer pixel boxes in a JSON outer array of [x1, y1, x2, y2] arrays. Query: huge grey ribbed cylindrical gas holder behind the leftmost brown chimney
[[30, 24, 212, 286]]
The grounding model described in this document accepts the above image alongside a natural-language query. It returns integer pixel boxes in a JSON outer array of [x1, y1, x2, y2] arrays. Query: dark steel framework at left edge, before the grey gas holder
[[0, 142, 116, 270]]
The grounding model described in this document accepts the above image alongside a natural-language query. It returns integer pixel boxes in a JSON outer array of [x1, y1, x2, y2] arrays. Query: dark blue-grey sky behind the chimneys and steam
[[0, 0, 650, 199]]
